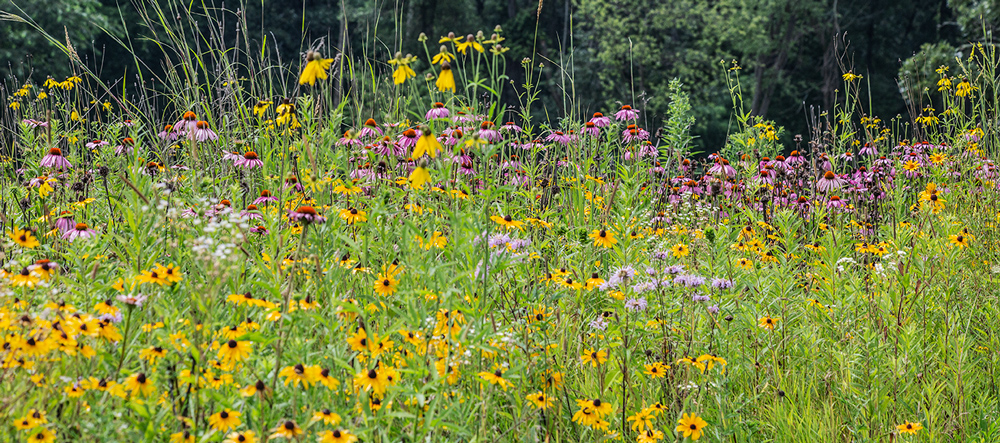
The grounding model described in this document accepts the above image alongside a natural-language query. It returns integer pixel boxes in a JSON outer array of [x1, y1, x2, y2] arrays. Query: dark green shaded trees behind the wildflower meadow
[[0, 0, 1000, 151]]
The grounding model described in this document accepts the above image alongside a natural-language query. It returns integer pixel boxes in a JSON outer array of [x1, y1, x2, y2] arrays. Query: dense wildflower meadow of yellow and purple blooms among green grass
[[0, 12, 1000, 443]]
